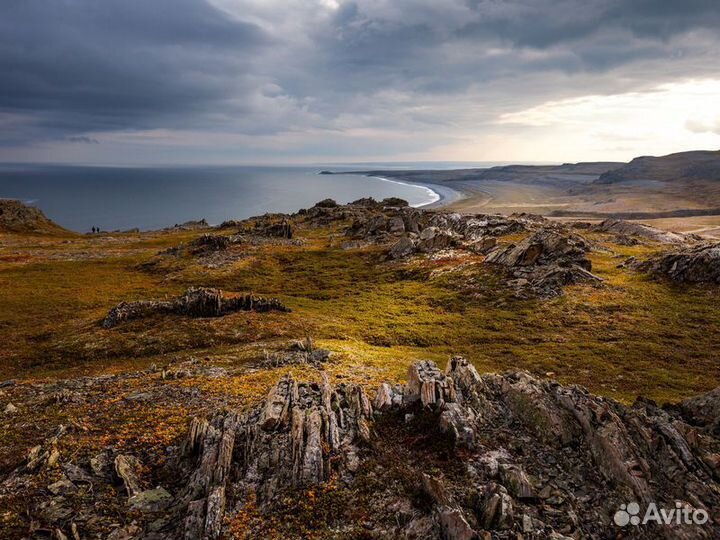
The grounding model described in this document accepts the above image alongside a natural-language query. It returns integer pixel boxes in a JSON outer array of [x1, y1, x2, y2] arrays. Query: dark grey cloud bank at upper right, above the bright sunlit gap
[[318, 0, 720, 91]]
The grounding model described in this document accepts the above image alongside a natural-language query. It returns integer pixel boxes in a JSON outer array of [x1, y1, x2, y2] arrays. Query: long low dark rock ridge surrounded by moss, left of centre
[[102, 287, 290, 328]]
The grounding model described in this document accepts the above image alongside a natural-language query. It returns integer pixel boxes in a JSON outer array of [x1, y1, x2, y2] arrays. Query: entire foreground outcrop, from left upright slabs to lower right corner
[[163, 357, 720, 540]]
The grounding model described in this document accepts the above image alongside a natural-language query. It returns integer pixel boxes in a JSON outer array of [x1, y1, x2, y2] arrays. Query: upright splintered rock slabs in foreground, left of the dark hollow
[[174, 376, 372, 538]]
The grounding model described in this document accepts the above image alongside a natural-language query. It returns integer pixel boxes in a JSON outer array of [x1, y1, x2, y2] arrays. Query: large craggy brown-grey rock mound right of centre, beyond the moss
[[485, 228, 601, 297]]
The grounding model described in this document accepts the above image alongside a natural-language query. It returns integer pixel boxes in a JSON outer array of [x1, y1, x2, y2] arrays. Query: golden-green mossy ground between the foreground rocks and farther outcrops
[[0, 229, 720, 402]]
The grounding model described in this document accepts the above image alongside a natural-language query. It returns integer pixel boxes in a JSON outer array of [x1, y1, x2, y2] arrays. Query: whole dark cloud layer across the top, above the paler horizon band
[[0, 0, 720, 153]]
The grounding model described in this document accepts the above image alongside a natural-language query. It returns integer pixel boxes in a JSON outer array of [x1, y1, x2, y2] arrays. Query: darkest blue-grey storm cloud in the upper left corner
[[0, 0, 268, 141]]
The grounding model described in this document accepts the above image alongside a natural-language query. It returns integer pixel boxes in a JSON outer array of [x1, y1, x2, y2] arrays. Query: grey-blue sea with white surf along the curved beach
[[0, 163, 498, 232]]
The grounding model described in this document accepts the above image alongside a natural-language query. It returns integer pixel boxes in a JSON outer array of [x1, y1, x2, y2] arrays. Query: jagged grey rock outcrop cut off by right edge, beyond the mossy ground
[[634, 243, 720, 284]]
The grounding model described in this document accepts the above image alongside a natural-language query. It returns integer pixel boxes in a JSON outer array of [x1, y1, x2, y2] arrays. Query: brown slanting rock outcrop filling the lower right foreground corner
[[378, 358, 720, 539]]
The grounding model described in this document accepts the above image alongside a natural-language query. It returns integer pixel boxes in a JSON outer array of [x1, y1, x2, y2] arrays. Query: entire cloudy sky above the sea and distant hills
[[0, 0, 720, 165]]
